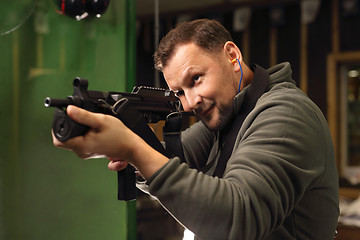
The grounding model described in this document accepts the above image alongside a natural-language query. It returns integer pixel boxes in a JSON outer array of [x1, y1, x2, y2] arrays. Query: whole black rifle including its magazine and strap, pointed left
[[44, 78, 181, 201]]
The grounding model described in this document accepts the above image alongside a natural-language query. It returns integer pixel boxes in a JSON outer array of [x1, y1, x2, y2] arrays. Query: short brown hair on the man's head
[[154, 19, 232, 71]]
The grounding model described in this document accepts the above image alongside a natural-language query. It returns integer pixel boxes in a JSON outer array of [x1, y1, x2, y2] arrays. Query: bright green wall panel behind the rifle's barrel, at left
[[0, 0, 135, 240]]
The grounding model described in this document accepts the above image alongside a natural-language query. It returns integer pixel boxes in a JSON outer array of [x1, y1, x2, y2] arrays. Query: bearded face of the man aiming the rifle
[[163, 43, 238, 130]]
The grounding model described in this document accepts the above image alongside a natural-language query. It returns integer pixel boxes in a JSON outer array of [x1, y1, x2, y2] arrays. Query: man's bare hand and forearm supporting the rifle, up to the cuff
[[53, 105, 168, 178]]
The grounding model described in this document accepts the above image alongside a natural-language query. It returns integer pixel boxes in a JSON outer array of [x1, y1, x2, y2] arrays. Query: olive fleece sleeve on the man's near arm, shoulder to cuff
[[149, 87, 327, 239]]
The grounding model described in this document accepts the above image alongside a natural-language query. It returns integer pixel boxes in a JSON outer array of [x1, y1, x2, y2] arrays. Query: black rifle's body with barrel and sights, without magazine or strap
[[45, 78, 180, 142]]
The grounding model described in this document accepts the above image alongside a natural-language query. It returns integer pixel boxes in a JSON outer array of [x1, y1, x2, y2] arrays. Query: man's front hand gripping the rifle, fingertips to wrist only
[[53, 106, 140, 161]]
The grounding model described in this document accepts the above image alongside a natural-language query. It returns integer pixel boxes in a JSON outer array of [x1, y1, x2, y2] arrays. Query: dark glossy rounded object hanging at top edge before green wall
[[56, 0, 110, 20]]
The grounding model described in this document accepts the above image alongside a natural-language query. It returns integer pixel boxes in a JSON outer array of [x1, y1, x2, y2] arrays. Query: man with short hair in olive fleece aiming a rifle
[[54, 19, 338, 239]]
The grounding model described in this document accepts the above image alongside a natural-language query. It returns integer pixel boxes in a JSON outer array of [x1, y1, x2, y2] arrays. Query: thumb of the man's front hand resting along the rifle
[[66, 105, 100, 129]]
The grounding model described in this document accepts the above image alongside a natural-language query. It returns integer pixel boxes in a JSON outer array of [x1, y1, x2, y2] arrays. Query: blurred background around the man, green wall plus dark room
[[0, 0, 360, 240]]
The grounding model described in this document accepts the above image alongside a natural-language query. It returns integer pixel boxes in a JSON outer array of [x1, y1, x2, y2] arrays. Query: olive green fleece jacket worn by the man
[[147, 63, 339, 240]]
